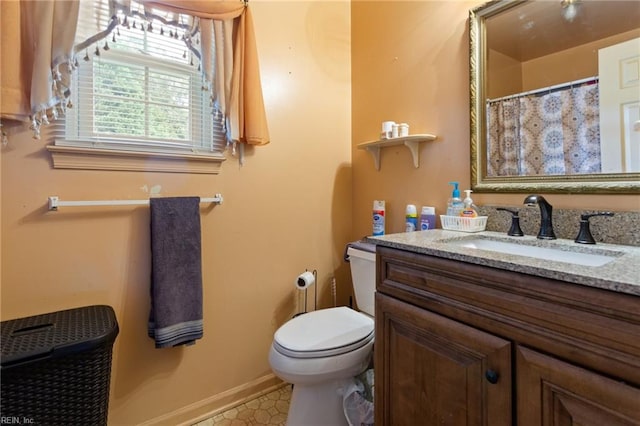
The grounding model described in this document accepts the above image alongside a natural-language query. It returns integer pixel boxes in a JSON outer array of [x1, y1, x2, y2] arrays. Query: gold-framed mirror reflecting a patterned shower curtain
[[469, 0, 640, 193]]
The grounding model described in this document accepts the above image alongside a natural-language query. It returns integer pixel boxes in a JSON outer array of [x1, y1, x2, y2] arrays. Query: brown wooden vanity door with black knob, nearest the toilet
[[375, 293, 510, 426]]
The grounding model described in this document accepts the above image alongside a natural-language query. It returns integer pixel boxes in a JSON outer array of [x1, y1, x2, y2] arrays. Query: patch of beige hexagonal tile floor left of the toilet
[[193, 385, 291, 426]]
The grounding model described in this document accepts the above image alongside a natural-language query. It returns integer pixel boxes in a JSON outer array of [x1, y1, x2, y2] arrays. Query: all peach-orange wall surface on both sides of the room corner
[[1, 0, 638, 425]]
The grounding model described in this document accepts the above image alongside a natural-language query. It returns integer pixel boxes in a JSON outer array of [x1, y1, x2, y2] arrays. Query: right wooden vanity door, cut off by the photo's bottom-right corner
[[516, 346, 640, 426]]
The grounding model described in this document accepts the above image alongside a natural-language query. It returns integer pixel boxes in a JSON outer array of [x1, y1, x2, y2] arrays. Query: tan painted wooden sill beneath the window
[[47, 145, 226, 174]]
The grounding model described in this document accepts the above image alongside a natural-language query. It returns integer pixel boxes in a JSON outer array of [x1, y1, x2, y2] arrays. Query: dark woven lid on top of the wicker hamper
[[0, 305, 118, 368]]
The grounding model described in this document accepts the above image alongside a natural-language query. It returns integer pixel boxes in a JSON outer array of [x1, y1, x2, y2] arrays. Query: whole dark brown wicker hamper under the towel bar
[[0, 305, 118, 425]]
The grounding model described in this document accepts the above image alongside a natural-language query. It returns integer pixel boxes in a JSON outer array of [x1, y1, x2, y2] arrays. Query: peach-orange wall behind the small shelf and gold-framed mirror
[[351, 1, 640, 241]]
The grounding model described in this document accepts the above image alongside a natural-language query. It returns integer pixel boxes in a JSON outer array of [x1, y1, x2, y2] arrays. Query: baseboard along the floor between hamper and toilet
[[139, 373, 285, 426]]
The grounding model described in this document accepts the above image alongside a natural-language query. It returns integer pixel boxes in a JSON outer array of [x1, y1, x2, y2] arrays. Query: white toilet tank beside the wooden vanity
[[345, 241, 376, 316]]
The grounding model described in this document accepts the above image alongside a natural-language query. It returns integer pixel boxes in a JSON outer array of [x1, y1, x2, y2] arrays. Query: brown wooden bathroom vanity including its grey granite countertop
[[368, 230, 640, 426]]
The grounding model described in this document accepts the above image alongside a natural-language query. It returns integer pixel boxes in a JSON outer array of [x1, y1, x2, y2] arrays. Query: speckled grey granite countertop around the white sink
[[366, 229, 640, 296]]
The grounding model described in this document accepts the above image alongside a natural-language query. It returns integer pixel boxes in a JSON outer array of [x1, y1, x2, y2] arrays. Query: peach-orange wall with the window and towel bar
[[1, 0, 352, 425]]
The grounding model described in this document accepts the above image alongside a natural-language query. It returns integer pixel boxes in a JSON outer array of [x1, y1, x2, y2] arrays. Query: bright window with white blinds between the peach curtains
[[56, 0, 226, 155]]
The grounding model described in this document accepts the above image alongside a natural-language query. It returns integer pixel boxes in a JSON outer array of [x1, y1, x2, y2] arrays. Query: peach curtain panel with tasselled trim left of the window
[[0, 0, 78, 137]]
